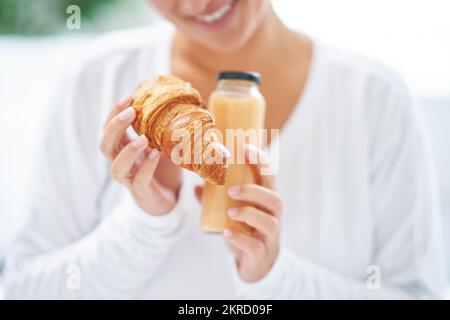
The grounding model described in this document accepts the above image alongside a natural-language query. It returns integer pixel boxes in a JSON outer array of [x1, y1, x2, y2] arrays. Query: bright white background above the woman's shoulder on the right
[[273, 0, 450, 96]]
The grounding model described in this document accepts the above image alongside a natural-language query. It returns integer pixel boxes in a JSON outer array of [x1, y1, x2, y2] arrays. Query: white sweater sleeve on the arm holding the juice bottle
[[232, 72, 446, 299]]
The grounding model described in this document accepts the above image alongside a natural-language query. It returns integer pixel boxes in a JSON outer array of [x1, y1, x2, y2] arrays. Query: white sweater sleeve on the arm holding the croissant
[[4, 56, 186, 299]]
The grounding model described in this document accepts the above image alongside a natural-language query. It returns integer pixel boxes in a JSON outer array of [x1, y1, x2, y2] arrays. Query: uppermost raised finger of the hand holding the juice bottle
[[244, 144, 275, 190]]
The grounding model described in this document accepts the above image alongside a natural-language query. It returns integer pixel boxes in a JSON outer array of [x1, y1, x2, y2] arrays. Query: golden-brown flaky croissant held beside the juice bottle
[[133, 76, 231, 185]]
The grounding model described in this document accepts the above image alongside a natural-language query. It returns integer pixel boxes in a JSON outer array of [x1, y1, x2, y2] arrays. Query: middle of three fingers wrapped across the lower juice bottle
[[228, 206, 279, 236]]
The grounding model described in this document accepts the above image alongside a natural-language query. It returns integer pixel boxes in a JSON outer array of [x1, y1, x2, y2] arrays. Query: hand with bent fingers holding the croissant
[[100, 97, 181, 215]]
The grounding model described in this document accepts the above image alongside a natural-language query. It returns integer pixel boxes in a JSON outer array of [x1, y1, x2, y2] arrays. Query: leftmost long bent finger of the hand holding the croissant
[[100, 107, 136, 160]]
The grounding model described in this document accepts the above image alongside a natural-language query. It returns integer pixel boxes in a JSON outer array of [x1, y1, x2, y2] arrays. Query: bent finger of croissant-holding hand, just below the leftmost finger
[[110, 135, 148, 183]]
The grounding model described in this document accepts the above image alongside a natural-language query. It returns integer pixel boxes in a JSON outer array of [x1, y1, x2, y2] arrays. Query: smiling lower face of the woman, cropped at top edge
[[150, 0, 270, 52]]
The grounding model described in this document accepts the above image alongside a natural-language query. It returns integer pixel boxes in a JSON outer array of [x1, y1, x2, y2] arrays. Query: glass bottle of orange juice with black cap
[[202, 71, 266, 232]]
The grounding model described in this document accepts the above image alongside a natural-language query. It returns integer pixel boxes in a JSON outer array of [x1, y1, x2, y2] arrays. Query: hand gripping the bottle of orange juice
[[196, 145, 283, 282]]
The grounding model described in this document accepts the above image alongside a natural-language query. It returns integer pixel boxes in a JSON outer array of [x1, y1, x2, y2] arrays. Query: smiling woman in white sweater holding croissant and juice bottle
[[6, 0, 445, 299]]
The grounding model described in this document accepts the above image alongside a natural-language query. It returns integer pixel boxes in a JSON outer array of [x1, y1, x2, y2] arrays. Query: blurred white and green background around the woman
[[0, 0, 450, 297]]
